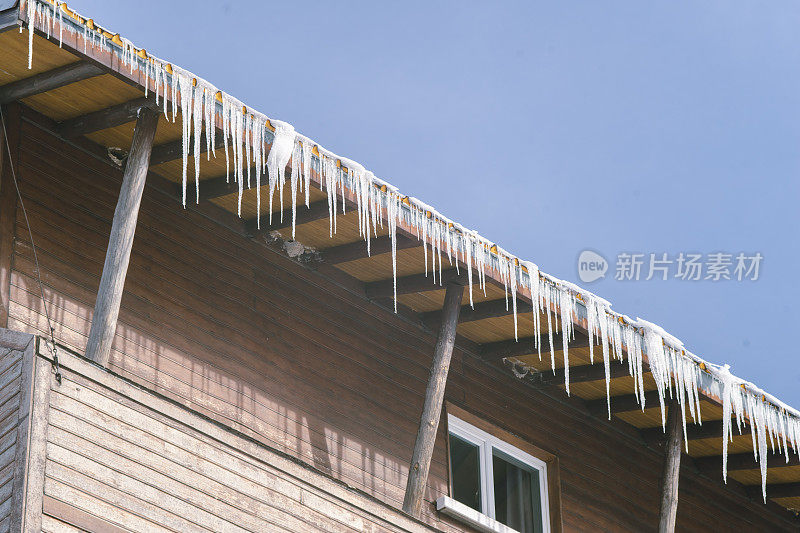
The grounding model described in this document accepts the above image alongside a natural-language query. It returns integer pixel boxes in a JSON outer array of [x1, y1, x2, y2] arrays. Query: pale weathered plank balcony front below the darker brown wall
[[43, 344, 432, 533]]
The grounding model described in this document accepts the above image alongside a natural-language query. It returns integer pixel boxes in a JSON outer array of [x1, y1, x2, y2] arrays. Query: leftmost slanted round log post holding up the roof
[[86, 107, 158, 365]]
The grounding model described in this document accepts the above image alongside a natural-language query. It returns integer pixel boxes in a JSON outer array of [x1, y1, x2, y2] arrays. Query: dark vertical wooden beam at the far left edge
[[0, 104, 20, 328]]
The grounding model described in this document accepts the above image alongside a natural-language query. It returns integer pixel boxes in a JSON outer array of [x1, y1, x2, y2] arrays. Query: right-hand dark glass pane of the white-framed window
[[492, 450, 542, 533]]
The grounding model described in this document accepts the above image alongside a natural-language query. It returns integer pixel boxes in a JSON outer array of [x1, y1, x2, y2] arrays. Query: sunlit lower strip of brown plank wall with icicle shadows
[[4, 268, 447, 507]]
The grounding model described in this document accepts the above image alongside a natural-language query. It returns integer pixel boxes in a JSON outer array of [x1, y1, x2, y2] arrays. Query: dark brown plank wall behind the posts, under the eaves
[[9, 110, 800, 531]]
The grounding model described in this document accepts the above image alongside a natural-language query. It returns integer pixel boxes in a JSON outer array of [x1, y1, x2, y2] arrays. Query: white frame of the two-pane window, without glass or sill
[[447, 413, 550, 533]]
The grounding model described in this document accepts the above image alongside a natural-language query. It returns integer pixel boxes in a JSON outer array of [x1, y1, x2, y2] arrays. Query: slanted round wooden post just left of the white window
[[403, 282, 464, 517]]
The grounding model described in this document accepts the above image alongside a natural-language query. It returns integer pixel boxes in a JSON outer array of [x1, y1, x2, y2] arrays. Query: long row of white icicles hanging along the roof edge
[[20, 0, 800, 499]]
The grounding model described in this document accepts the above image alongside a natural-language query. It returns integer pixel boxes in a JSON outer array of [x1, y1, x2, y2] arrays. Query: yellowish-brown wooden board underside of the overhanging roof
[[0, 2, 800, 510]]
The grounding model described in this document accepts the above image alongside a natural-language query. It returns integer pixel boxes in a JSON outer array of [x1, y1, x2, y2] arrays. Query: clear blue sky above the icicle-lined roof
[[70, 0, 800, 408]]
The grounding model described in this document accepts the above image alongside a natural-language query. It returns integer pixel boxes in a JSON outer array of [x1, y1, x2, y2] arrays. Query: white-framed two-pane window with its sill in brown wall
[[437, 413, 550, 533]]
